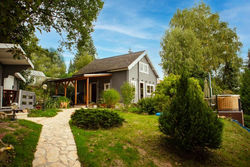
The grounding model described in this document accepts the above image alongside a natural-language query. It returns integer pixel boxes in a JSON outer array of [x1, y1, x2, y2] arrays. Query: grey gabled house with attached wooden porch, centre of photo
[[52, 51, 158, 104]]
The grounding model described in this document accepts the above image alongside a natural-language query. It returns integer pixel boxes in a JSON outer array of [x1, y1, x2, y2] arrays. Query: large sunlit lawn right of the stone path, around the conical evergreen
[[71, 112, 250, 167]]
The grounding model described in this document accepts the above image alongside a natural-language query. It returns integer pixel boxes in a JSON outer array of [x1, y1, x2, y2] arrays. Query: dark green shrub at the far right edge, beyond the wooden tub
[[240, 69, 250, 115]]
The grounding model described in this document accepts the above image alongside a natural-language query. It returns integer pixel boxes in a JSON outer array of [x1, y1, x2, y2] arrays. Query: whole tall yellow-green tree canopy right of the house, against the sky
[[160, 2, 242, 90]]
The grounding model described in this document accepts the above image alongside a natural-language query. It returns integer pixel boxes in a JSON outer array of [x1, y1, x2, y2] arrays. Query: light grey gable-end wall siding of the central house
[[128, 57, 157, 102]]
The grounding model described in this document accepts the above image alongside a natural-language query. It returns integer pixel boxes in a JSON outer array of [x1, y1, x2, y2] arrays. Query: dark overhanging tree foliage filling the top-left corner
[[0, 0, 103, 51]]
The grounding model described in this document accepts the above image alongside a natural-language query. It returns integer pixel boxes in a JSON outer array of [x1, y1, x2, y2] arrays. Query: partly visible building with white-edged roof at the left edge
[[0, 43, 35, 111]]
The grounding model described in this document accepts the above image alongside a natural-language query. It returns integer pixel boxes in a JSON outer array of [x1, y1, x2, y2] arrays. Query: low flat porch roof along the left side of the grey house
[[47, 73, 112, 82]]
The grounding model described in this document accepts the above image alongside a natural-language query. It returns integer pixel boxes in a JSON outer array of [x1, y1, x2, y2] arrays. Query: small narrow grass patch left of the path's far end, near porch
[[28, 109, 60, 117]]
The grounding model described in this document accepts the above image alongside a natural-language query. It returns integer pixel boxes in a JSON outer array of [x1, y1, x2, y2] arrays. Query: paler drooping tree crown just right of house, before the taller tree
[[161, 28, 205, 75]]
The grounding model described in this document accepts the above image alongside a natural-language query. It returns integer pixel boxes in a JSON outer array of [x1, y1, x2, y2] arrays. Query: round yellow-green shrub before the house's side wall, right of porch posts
[[102, 89, 120, 108]]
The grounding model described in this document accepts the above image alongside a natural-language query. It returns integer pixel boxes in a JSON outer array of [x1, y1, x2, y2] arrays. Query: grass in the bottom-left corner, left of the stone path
[[0, 120, 42, 167]]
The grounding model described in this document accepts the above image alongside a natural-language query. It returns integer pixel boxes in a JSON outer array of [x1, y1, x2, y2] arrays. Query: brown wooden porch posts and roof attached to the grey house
[[49, 73, 112, 105]]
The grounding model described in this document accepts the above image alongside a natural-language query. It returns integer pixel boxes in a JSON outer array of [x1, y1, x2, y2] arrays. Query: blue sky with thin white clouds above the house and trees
[[36, 0, 250, 78]]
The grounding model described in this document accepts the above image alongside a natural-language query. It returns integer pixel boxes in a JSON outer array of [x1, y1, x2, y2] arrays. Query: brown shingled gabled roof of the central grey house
[[75, 51, 145, 75]]
